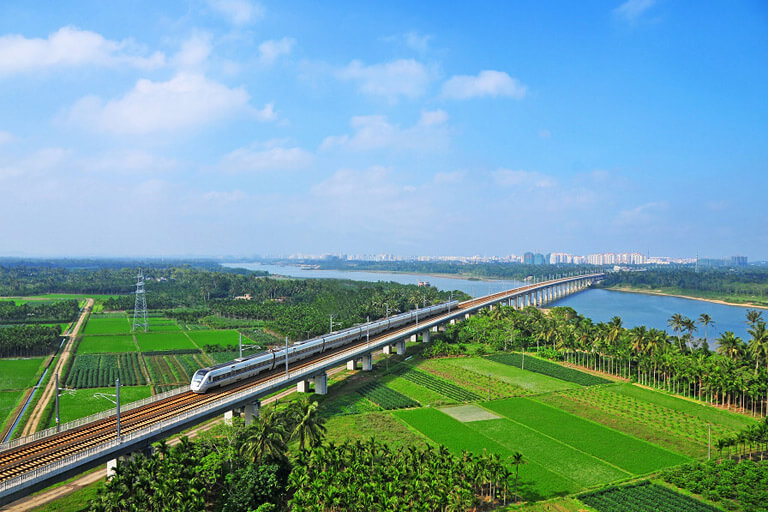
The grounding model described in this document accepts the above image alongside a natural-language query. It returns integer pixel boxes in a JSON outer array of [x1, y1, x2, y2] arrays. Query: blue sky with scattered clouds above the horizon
[[0, 0, 768, 259]]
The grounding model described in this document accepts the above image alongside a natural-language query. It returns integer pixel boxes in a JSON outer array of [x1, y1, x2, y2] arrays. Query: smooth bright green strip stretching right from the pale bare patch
[[483, 398, 690, 475]]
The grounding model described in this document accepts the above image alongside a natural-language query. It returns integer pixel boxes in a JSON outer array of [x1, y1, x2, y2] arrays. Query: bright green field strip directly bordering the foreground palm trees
[[392, 408, 583, 500]]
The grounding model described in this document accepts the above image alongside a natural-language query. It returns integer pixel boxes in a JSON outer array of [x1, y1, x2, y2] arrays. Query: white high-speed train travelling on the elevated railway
[[189, 300, 459, 393]]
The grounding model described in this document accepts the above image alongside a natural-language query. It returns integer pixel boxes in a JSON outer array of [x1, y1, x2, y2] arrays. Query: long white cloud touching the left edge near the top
[[0, 27, 165, 75]]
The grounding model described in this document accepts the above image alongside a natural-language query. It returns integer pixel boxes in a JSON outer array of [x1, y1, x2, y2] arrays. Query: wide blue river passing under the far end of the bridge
[[223, 263, 752, 347]]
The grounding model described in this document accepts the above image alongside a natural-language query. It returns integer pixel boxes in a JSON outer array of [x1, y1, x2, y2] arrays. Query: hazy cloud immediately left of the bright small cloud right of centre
[[338, 59, 432, 100]]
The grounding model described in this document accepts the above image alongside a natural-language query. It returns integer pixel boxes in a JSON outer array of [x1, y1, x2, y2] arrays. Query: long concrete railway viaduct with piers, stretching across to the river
[[0, 273, 604, 505]]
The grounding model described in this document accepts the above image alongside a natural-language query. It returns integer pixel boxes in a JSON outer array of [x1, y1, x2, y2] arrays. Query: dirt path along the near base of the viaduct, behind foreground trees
[[0, 366, 346, 512]]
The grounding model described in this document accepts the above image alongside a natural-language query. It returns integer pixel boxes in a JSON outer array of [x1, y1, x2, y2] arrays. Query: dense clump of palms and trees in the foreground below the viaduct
[[89, 397, 524, 512]]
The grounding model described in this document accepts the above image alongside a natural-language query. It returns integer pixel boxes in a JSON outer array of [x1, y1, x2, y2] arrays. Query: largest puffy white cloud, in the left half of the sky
[[69, 73, 275, 134]]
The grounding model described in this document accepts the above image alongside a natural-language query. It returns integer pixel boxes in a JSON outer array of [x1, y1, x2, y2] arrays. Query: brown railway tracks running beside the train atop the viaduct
[[0, 278, 592, 482]]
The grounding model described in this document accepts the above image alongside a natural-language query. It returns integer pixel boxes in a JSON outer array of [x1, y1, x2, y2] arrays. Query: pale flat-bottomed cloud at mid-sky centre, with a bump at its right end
[[320, 110, 448, 151]]
